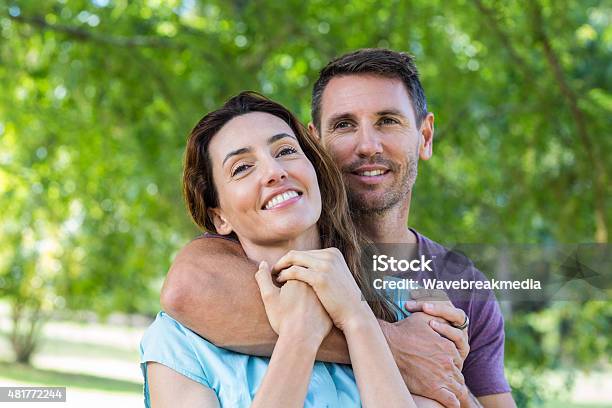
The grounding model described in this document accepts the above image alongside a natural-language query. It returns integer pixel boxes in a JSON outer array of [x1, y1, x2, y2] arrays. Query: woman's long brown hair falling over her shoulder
[[183, 91, 397, 322]]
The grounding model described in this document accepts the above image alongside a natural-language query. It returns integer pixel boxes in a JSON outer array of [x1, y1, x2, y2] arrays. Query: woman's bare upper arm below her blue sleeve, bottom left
[[147, 362, 219, 408]]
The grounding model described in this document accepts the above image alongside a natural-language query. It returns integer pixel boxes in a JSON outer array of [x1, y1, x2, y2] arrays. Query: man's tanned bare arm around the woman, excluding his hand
[[161, 237, 350, 364]]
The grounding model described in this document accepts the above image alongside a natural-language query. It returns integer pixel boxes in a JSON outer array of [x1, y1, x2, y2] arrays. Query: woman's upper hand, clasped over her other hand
[[273, 248, 373, 330]]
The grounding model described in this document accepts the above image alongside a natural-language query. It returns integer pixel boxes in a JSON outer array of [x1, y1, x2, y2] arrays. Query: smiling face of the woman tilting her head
[[209, 112, 321, 245]]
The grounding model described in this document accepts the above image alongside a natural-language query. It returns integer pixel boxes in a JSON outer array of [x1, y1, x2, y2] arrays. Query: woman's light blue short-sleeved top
[[140, 280, 405, 408]]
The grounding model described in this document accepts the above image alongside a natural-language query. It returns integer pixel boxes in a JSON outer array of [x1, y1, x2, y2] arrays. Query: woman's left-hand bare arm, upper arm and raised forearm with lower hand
[[147, 278, 332, 408]]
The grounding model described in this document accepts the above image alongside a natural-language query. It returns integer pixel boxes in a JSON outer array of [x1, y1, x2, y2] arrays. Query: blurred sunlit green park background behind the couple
[[0, 0, 612, 408]]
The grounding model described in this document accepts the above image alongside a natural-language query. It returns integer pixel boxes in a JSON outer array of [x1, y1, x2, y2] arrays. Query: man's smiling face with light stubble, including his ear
[[311, 75, 433, 213]]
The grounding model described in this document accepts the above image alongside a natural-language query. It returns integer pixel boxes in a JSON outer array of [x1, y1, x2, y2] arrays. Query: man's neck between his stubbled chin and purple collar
[[357, 194, 417, 244]]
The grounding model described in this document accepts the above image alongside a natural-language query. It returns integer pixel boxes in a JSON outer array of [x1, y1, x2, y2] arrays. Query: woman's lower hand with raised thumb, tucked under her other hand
[[255, 262, 332, 349]]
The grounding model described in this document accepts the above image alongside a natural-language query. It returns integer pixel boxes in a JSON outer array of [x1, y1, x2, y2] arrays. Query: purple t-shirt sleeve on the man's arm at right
[[463, 278, 510, 397]]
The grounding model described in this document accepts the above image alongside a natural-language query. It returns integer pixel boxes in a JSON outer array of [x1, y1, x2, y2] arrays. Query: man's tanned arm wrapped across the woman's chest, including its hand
[[161, 238, 474, 407]]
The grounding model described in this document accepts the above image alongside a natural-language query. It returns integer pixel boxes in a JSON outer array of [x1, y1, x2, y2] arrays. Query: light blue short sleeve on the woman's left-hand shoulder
[[140, 312, 212, 388]]
